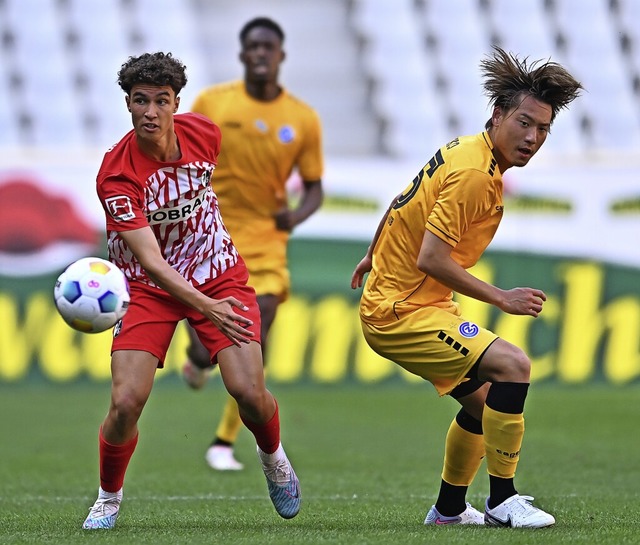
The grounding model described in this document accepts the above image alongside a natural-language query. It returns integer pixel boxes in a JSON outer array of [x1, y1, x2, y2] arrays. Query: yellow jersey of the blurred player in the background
[[192, 81, 323, 258]]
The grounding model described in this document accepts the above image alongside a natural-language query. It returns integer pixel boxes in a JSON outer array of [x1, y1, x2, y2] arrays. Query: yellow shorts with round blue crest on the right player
[[361, 307, 498, 396]]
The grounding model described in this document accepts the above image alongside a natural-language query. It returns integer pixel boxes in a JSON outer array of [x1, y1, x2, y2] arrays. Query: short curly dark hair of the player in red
[[118, 51, 187, 96]]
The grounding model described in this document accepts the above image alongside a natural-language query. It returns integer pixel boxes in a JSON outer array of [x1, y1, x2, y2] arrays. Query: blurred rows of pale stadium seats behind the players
[[0, 0, 640, 154]]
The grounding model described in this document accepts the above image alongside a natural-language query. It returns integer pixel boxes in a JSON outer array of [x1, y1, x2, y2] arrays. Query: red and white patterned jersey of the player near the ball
[[97, 113, 238, 286]]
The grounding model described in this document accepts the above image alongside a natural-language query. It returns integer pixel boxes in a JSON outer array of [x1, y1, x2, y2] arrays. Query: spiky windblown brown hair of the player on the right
[[480, 46, 583, 129]]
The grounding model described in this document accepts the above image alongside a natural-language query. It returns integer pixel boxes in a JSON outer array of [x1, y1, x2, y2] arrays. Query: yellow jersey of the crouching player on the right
[[360, 132, 503, 323]]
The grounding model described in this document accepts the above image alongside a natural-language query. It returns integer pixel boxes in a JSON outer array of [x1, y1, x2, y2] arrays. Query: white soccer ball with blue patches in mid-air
[[53, 257, 129, 333]]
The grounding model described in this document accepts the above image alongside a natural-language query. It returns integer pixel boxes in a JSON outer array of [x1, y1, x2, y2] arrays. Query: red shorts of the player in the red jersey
[[111, 261, 260, 367]]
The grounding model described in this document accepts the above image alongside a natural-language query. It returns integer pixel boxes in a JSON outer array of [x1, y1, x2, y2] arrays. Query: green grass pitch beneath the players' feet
[[0, 379, 640, 545]]
